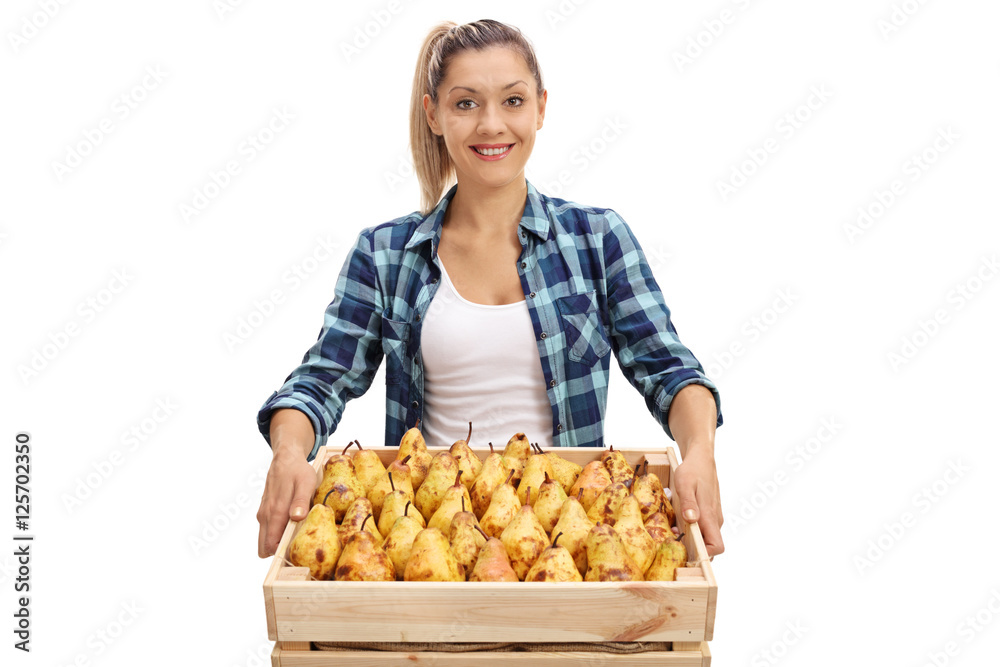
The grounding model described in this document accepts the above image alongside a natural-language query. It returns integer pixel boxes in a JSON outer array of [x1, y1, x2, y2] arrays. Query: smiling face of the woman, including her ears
[[424, 47, 548, 193]]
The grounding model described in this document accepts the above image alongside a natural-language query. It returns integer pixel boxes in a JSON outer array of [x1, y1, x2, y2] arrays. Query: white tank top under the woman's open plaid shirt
[[420, 258, 552, 451]]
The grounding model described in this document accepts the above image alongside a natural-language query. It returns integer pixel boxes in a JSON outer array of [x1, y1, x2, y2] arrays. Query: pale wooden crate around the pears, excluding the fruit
[[264, 447, 718, 666]]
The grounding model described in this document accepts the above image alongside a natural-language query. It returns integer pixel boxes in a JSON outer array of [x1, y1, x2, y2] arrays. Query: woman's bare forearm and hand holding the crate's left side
[[257, 409, 317, 558]]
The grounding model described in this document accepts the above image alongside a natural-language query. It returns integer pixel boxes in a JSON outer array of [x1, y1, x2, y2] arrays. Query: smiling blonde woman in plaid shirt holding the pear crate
[[257, 20, 723, 557]]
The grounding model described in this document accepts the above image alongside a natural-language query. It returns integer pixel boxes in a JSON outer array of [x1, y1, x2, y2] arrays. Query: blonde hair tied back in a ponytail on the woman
[[410, 19, 545, 215]]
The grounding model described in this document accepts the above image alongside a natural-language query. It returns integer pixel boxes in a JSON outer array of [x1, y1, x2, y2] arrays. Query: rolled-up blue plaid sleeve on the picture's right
[[604, 210, 722, 440]]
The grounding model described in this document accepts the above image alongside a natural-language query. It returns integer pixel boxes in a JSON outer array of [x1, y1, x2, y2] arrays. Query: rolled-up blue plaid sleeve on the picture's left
[[257, 233, 383, 461]]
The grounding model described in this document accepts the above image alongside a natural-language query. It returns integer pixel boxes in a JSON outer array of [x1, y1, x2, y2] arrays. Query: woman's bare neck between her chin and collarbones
[[443, 175, 528, 235]]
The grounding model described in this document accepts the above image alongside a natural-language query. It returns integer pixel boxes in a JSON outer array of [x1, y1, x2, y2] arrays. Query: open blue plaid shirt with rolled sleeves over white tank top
[[257, 183, 722, 460]]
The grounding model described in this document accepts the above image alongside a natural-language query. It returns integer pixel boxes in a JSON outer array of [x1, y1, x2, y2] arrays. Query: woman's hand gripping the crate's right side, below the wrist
[[673, 446, 726, 556]]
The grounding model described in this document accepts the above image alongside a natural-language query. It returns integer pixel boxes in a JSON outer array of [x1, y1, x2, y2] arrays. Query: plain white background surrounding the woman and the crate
[[0, 0, 1000, 667]]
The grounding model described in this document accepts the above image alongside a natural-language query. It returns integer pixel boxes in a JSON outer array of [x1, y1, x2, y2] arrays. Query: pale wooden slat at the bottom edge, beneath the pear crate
[[271, 642, 712, 667]]
